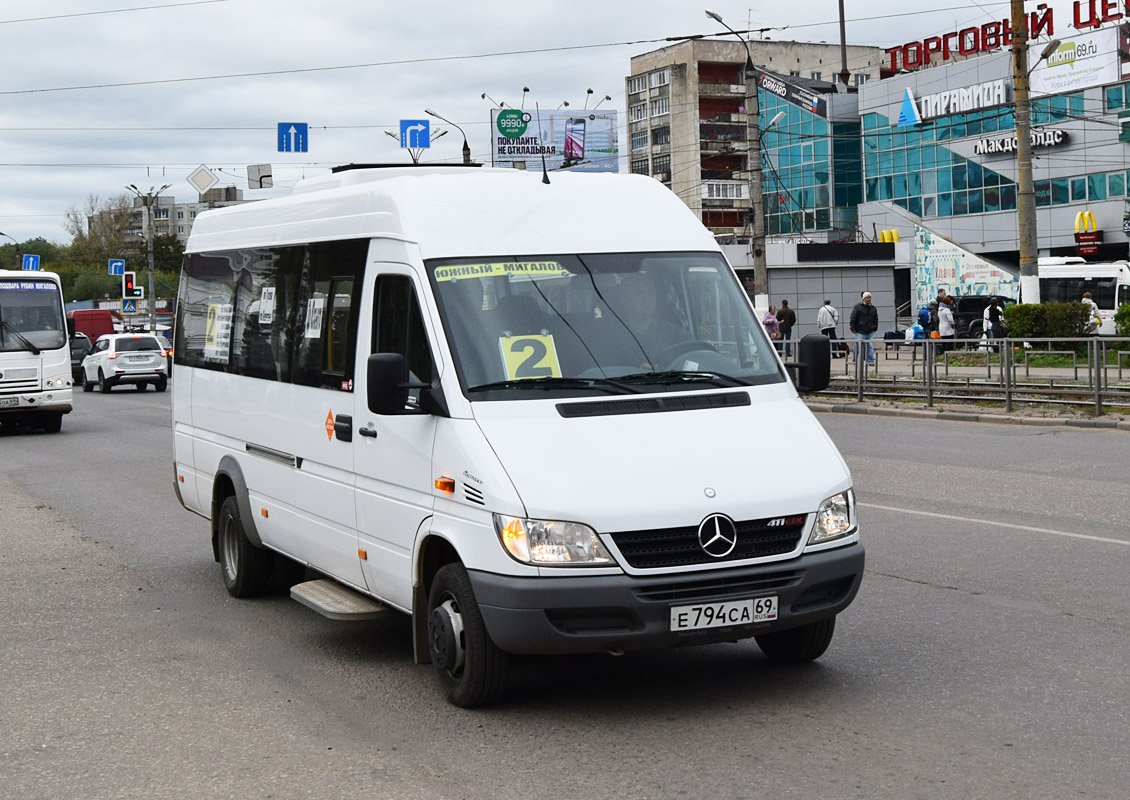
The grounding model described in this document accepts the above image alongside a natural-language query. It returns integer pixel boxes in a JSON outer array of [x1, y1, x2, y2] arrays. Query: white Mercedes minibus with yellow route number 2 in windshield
[[173, 167, 863, 706]]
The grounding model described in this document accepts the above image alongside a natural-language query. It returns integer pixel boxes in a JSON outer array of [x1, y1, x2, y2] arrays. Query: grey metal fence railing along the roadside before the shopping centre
[[825, 337, 1130, 414]]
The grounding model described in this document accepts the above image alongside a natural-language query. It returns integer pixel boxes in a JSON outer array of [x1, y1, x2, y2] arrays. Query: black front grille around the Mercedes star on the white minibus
[[610, 514, 808, 569]]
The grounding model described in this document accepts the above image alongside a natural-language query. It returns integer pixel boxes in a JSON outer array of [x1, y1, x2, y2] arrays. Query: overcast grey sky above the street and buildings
[[0, 0, 1071, 243]]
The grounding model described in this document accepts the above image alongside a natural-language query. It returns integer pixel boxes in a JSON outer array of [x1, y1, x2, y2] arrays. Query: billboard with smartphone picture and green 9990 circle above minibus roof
[[490, 108, 619, 172]]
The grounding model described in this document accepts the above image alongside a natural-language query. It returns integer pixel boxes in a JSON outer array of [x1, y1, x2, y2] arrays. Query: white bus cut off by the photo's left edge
[[0, 270, 72, 433]]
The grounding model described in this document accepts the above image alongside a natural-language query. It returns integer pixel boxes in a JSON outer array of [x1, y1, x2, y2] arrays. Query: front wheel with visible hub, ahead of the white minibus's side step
[[427, 563, 510, 708]]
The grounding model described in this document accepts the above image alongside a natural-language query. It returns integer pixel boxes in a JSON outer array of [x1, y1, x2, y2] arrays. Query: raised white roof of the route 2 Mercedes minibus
[[185, 166, 719, 259]]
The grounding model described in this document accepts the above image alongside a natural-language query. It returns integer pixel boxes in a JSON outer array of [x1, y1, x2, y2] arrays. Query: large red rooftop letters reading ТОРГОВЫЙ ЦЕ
[[885, 0, 1127, 72]]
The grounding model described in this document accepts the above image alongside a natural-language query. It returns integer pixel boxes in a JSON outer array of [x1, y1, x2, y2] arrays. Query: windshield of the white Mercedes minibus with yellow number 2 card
[[427, 253, 785, 399]]
